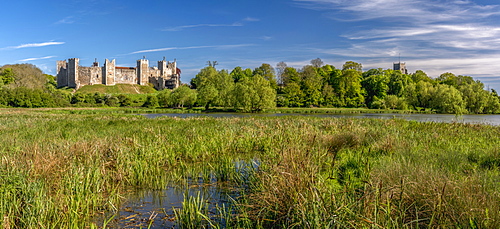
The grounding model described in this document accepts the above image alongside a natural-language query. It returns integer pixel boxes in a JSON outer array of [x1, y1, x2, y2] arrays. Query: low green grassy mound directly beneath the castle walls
[[78, 84, 156, 94]]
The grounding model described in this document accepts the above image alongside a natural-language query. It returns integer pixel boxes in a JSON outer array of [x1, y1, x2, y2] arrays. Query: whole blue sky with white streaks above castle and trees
[[0, 0, 500, 91]]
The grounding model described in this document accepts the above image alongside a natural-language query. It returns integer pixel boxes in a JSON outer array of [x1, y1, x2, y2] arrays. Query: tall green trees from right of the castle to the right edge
[[191, 58, 500, 114]]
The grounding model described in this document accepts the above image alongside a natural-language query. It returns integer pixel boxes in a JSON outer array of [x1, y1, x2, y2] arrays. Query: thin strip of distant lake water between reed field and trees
[[142, 113, 500, 126]]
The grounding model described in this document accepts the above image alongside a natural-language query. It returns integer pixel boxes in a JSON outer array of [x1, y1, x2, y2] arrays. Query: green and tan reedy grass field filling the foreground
[[0, 109, 500, 228]]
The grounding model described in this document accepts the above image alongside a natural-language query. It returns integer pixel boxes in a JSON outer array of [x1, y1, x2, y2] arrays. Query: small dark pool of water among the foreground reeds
[[96, 181, 240, 228]]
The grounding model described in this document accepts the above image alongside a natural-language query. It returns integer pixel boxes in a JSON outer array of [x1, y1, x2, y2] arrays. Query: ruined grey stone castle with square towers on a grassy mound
[[57, 57, 181, 90]]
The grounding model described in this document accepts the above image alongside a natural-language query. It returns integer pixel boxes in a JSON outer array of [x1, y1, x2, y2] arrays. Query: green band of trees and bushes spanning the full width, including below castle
[[0, 58, 500, 114]]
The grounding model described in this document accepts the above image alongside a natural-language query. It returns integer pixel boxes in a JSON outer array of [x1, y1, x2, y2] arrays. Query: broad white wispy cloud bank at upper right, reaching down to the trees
[[293, 0, 500, 85]]
